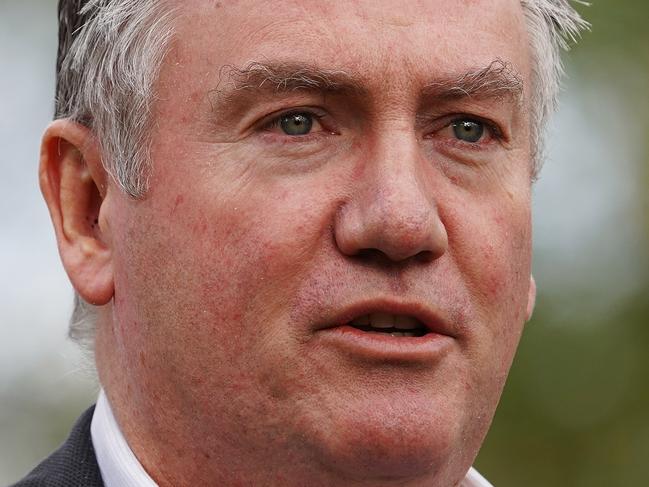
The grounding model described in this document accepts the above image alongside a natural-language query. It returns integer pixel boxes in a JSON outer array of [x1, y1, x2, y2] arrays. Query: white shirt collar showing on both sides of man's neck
[[90, 389, 493, 487]]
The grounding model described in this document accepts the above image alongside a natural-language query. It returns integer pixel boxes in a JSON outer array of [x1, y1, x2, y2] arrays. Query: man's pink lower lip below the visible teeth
[[319, 325, 454, 362]]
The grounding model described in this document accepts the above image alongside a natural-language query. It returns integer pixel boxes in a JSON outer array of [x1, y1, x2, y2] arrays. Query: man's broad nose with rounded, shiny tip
[[334, 134, 448, 262]]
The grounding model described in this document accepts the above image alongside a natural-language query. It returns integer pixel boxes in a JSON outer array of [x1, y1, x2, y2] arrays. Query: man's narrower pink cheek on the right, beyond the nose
[[446, 190, 531, 346]]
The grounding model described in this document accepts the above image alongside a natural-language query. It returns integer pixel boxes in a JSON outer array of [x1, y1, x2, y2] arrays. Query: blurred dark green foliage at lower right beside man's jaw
[[477, 292, 649, 487]]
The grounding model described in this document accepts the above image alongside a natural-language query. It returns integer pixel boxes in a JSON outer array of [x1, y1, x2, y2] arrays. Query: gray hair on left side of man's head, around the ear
[[55, 0, 173, 354]]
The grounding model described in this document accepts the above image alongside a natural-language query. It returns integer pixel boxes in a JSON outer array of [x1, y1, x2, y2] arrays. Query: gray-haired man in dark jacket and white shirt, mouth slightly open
[[12, 0, 584, 487]]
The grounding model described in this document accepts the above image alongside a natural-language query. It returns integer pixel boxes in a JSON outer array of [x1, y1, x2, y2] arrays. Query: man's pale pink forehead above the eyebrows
[[165, 0, 529, 86]]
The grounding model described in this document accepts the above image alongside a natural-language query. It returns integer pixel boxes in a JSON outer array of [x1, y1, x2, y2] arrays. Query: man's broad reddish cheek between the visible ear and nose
[[118, 182, 327, 331]]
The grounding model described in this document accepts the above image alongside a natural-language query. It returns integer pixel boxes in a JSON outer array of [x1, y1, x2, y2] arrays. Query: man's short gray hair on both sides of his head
[[55, 0, 588, 354]]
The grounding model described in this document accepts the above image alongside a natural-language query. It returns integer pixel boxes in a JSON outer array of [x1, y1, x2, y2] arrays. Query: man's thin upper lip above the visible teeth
[[318, 298, 457, 338]]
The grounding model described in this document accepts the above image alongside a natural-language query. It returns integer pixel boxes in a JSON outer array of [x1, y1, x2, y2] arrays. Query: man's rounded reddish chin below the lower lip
[[308, 398, 470, 487]]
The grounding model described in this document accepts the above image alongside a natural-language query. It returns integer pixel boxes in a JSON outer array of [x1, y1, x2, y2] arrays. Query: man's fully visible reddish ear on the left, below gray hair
[[39, 120, 114, 305]]
